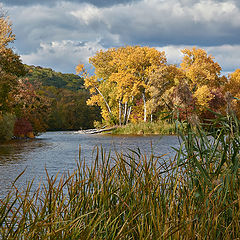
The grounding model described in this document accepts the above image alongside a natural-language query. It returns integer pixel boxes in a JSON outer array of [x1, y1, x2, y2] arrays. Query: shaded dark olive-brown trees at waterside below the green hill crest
[[42, 86, 101, 130]]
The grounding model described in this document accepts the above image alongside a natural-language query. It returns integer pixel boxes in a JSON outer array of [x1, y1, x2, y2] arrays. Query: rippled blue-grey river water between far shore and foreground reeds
[[0, 132, 179, 199]]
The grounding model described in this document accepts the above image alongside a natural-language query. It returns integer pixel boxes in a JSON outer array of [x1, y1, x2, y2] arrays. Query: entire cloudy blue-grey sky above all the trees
[[0, 0, 240, 74]]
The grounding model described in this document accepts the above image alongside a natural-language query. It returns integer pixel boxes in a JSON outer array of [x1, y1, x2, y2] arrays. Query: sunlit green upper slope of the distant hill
[[25, 65, 84, 91]]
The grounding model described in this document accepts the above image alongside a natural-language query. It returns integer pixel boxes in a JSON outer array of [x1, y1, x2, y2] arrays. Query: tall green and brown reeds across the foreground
[[0, 113, 240, 239]]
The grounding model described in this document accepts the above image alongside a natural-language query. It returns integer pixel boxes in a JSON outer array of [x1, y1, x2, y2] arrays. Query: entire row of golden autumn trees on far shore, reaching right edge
[[76, 46, 240, 125]]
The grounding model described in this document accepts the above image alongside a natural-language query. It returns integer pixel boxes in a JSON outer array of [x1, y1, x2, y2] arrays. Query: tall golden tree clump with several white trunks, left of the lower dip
[[78, 46, 166, 125]]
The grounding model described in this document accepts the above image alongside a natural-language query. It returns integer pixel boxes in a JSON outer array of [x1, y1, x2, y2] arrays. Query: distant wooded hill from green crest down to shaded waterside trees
[[22, 65, 101, 131]]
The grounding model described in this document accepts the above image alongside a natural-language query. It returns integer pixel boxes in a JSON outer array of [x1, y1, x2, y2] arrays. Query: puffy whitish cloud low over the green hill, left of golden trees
[[21, 40, 104, 72]]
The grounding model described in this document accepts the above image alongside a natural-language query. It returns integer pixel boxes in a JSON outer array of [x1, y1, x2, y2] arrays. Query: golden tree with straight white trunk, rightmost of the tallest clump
[[110, 46, 167, 122]]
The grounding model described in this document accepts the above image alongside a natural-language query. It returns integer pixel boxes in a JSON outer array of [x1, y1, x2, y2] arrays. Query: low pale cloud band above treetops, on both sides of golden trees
[[22, 39, 240, 75]]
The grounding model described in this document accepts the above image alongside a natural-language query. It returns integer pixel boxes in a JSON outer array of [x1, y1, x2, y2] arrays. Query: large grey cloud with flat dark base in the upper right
[[102, 0, 240, 46]]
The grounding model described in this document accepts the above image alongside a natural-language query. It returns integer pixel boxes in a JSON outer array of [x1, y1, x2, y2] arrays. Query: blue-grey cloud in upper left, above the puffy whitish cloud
[[8, 2, 118, 54]]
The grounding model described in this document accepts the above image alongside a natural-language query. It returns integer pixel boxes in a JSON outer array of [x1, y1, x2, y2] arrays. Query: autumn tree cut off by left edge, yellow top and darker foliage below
[[0, 11, 25, 141]]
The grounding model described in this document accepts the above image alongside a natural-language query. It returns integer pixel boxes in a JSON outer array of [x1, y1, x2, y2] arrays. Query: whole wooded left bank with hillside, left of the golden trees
[[0, 14, 101, 141]]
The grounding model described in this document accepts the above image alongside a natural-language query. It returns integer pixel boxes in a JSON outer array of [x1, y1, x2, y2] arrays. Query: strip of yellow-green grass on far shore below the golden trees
[[112, 121, 176, 135]]
